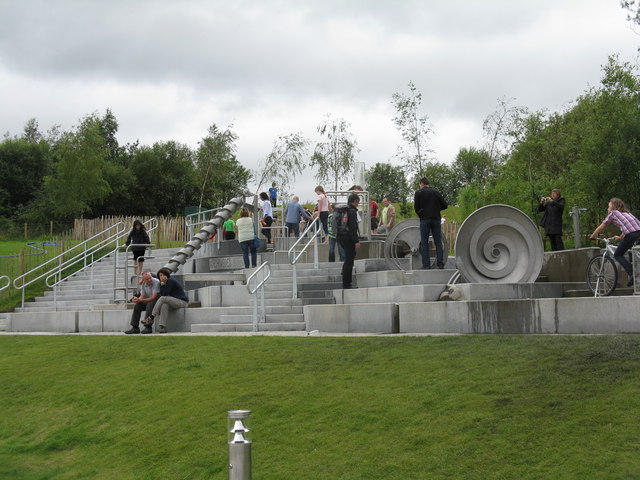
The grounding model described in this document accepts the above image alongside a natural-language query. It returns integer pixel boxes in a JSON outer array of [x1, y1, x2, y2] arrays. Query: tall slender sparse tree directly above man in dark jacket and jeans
[[391, 81, 433, 176]]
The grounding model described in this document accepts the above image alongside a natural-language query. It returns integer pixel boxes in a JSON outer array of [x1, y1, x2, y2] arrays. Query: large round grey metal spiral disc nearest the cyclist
[[456, 205, 544, 283]]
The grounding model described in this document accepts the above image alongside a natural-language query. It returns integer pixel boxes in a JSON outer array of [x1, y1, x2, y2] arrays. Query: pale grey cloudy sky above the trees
[[0, 0, 640, 199]]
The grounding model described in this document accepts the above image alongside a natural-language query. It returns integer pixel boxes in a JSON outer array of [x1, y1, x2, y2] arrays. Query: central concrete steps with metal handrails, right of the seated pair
[[191, 262, 342, 333]]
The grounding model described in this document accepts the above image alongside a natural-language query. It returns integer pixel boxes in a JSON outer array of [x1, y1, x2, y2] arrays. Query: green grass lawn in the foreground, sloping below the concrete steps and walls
[[0, 335, 640, 480]]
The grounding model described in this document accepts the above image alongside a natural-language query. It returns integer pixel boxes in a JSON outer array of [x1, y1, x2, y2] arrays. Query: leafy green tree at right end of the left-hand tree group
[[195, 124, 250, 208]]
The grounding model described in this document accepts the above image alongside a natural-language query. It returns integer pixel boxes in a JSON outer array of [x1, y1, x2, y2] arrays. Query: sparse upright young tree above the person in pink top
[[311, 115, 358, 190]]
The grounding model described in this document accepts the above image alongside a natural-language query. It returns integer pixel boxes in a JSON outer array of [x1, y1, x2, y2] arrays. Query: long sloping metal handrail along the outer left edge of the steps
[[13, 221, 125, 308]]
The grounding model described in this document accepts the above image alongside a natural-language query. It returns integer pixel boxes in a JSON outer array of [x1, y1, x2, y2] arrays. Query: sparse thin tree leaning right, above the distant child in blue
[[256, 133, 310, 196]]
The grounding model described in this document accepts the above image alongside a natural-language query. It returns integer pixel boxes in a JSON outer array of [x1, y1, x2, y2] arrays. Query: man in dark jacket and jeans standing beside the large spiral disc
[[413, 177, 448, 269]]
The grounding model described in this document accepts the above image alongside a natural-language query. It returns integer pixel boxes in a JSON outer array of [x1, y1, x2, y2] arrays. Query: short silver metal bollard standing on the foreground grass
[[227, 410, 251, 480]]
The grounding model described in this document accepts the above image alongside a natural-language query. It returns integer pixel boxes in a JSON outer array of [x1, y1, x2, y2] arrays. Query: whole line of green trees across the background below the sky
[[0, 57, 640, 237]]
